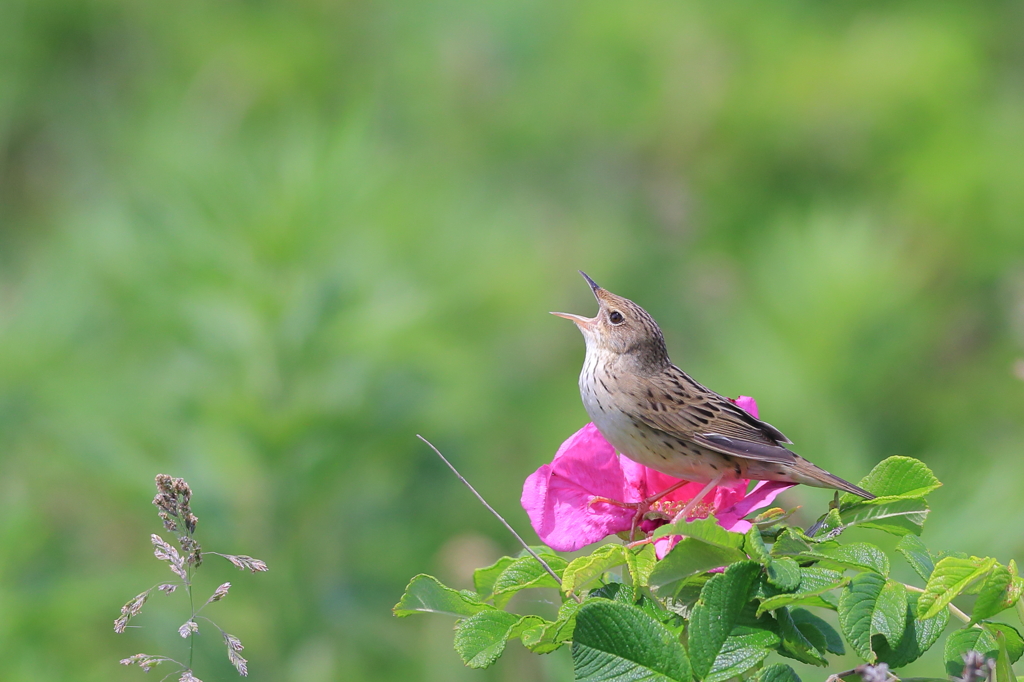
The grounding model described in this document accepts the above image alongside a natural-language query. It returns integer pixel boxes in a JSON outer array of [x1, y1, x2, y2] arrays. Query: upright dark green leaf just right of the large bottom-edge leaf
[[688, 561, 761, 679]]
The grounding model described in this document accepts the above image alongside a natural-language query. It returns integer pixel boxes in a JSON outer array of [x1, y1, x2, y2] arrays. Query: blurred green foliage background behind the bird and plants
[[0, 0, 1024, 682]]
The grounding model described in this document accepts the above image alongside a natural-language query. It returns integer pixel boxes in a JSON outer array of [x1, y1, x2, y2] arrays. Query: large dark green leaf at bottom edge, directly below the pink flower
[[572, 599, 692, 682]]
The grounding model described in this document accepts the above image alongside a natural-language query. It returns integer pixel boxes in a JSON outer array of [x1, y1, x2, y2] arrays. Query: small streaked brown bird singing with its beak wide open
[[552, 270, 874, 519]]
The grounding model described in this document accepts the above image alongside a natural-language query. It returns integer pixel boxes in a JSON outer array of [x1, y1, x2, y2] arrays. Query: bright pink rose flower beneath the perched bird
[[522, 396, 793, 559]]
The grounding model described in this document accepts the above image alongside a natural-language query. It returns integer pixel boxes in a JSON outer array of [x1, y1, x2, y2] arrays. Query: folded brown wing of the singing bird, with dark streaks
[[630, 368, 797, 463]]
